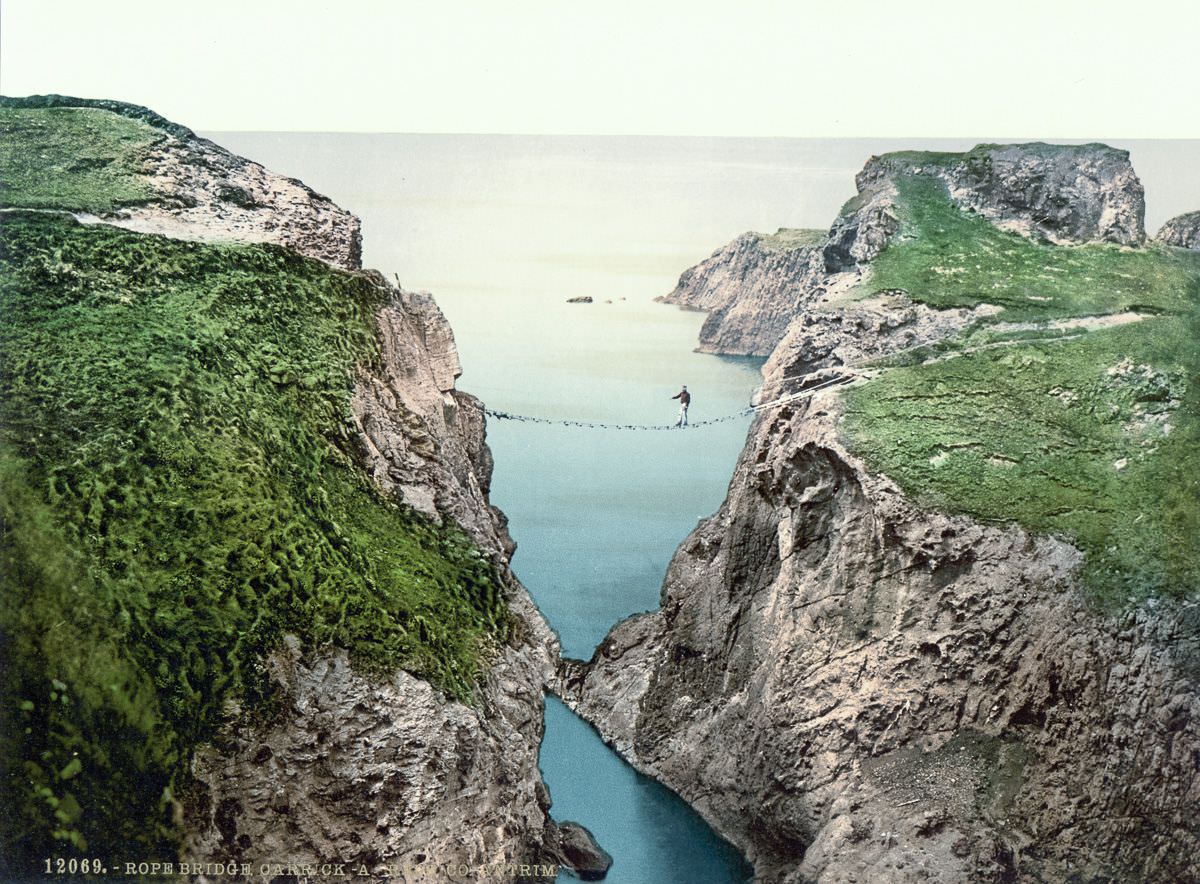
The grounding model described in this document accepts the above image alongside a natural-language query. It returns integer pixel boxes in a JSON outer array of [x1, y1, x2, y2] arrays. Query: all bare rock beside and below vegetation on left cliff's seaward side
[[180, 275, 562, 880]]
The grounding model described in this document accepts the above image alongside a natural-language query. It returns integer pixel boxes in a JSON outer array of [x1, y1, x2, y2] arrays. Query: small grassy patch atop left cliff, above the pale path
[[0, 106, 166, 214]]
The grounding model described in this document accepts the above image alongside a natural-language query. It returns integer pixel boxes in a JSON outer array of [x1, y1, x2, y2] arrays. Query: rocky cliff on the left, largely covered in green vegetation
[[0, 96, 595, 880]]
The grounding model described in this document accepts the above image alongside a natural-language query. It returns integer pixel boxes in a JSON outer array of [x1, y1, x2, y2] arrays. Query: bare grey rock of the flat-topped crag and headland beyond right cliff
[[660, 144, 1142, 356]]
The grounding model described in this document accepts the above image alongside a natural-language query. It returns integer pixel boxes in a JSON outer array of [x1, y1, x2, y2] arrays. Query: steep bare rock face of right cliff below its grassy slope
[[560, 393, 1200, 882]]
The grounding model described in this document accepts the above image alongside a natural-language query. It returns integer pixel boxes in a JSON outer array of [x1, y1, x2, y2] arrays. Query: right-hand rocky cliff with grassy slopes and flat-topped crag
[[559, 145, 1200, 882]]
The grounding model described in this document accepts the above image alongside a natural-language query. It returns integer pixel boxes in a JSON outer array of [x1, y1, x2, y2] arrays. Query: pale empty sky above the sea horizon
[[0, 0, 1200, 138]]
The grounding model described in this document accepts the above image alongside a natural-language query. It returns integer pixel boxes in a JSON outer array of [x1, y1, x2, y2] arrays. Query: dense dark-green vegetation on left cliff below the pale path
[[0, 212, 509, 874]]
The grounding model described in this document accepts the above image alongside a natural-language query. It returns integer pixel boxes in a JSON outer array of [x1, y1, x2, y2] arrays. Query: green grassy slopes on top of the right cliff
[[844, 170, 1200, 607]]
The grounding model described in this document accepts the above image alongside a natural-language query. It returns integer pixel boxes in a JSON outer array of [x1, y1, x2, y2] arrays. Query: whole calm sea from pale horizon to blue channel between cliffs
[[212, 132, 1200, 884]]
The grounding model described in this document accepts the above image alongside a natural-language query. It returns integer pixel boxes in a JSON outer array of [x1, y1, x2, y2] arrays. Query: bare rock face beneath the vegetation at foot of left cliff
[[190, 611, 553, 880]]
